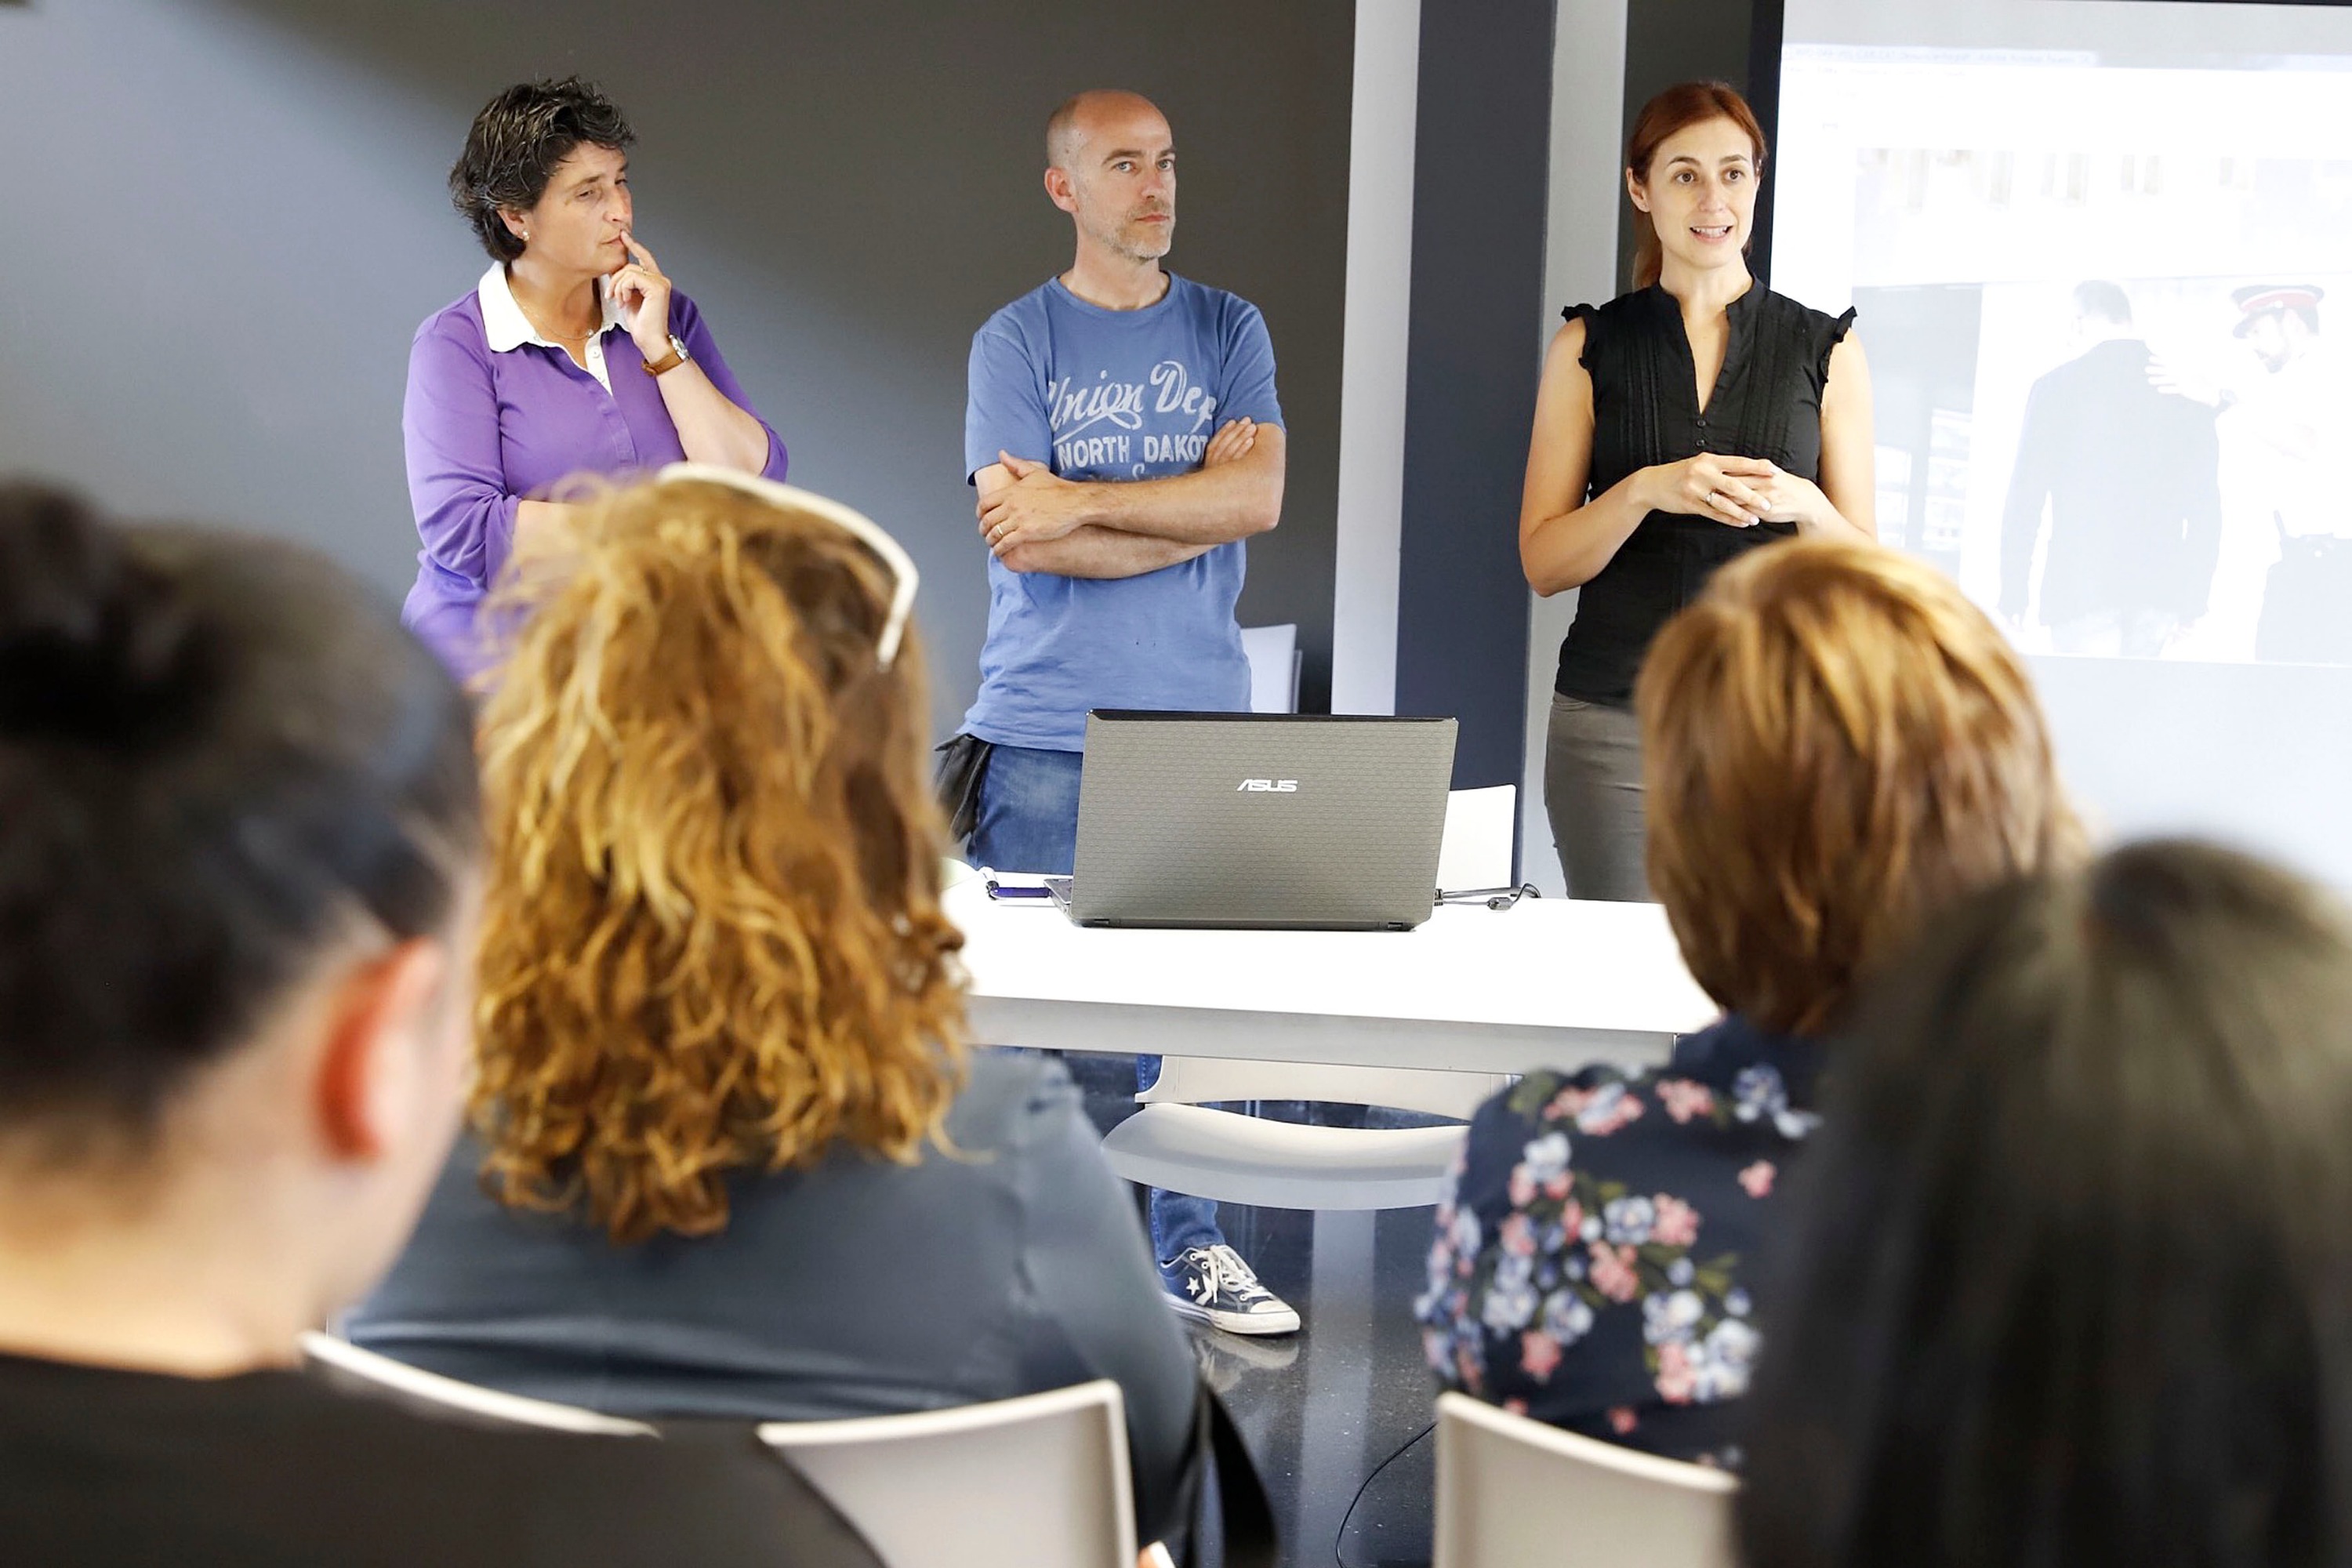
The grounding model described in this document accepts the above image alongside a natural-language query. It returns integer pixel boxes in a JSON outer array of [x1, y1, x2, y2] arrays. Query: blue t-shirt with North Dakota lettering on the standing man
[[964, 275, 1282, 753]]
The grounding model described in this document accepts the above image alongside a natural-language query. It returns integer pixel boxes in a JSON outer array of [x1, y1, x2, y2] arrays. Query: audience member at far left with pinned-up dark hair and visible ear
[[0, 487, 873, 1568]]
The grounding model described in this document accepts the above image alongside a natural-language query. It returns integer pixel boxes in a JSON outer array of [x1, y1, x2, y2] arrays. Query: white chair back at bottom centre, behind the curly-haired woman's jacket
[[760, 1380, 1136, 1568]]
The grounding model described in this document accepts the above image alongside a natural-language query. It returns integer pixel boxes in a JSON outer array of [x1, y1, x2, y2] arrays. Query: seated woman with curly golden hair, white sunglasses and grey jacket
[[350, 466, 1197, 1537]]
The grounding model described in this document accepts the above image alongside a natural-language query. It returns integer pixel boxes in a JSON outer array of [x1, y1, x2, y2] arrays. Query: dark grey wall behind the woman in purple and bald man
[[0, 0, 1352, 727]]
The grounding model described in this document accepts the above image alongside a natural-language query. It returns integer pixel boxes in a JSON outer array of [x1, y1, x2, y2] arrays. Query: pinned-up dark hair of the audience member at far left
[[0, 485, 480, 1159]]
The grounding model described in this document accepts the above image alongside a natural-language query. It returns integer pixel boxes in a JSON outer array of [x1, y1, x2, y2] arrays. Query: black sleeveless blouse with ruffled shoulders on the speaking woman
[[1552, 285, 1853, 708]]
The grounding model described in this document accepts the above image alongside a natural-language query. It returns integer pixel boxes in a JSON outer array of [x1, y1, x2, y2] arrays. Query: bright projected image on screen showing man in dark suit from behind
[[1771, 13, 2352, 666]]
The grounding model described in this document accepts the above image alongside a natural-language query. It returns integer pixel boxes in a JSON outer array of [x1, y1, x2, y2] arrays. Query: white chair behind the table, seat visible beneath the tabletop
[[1103, 785, 1519, 1210]]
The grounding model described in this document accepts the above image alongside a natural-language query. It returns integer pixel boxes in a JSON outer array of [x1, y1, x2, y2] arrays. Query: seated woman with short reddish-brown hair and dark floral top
[[1416, 541, 2074, 1465]]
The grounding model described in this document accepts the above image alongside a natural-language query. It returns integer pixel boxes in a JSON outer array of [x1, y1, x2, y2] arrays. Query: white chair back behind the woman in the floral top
[[1435, 1394, 1740, 1568]]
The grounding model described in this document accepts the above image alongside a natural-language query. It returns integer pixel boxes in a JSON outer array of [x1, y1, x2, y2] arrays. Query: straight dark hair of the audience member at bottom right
[[1738, 841, 2352, 1568]]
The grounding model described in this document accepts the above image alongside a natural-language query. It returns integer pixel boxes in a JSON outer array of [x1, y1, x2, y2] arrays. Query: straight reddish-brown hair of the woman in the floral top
[[1635, 541, 2079, 1034]]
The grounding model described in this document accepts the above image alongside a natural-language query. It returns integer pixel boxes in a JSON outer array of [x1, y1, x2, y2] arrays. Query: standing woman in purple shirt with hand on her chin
[[400, 78, 786, 677]]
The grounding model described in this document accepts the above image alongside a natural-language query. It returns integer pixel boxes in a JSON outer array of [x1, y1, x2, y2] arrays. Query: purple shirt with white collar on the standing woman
[[400, 266, 786, 680]]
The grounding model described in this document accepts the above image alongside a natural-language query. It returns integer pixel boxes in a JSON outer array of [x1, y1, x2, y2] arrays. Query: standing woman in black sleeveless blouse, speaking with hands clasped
[[1519, 82, 1877, 900]]
